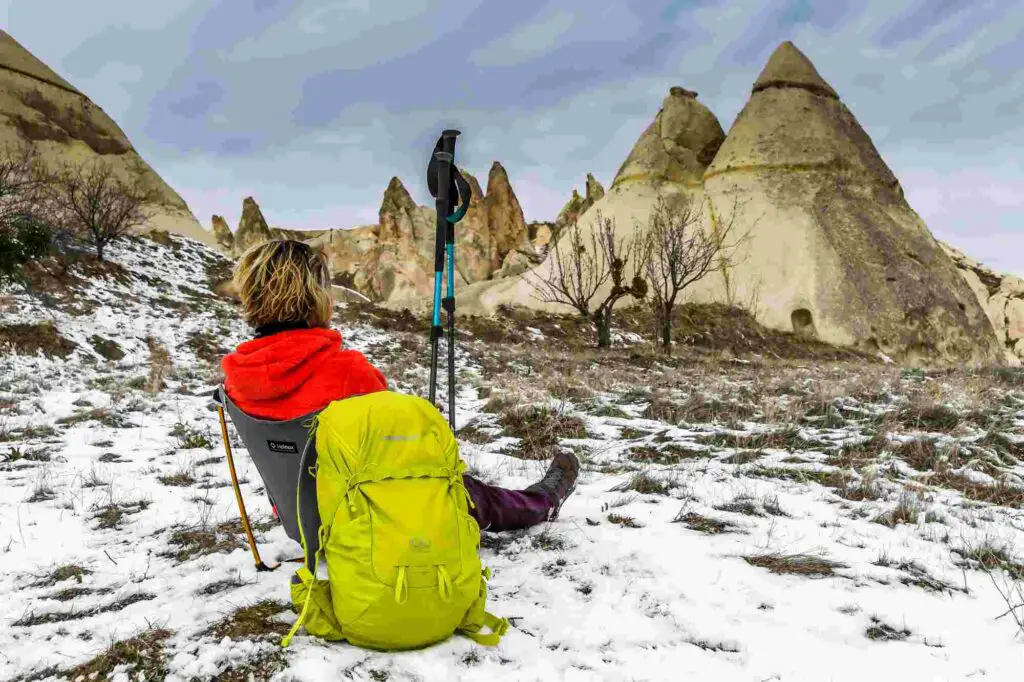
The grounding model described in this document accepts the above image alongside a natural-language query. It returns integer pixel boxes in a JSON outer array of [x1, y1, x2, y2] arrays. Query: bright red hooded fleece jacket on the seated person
[[221, 329, 387, 420]]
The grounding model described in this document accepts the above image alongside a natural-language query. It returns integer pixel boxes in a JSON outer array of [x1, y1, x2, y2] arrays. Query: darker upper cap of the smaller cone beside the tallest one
[[611, 86, 725, 187]]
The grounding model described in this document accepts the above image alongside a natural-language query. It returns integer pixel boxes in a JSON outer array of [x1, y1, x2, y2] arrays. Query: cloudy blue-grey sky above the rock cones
[[6, 0, 1024, 274]]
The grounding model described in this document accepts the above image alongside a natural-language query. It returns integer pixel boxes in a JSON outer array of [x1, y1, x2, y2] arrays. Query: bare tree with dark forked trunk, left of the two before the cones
[[523, 212, 647, 348]]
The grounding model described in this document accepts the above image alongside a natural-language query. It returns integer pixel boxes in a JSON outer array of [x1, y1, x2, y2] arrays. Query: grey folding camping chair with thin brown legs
[[213, 386, 319, 571]]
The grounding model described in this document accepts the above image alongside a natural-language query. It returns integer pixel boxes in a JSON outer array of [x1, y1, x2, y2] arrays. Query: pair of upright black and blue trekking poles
[[427, 130, 470, 430]]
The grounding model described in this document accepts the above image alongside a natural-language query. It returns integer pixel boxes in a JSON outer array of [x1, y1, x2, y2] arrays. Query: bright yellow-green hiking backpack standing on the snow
[[282, 391, 509, 650]]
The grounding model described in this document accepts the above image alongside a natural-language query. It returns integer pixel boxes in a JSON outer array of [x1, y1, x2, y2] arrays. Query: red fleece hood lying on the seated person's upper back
[[221, 329, 341, 401]]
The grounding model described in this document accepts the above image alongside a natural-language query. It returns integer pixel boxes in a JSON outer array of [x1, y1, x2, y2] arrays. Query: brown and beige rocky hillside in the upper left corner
[[0, 31, 216, 246]]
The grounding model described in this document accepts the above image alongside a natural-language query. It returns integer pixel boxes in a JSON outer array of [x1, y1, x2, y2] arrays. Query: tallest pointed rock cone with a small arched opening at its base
[[701, 43, 1001, 364]]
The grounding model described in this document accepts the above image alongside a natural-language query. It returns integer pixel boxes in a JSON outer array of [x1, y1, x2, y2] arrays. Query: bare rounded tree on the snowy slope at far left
[[47, 156, 157, 261]]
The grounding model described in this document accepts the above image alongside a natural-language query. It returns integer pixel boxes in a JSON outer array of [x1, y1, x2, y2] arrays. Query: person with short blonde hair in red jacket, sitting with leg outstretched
[[221, 240, 580, 531]]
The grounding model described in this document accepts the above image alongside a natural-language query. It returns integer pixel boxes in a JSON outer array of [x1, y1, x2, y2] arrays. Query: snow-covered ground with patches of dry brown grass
[[0, 239, 1024, 682]]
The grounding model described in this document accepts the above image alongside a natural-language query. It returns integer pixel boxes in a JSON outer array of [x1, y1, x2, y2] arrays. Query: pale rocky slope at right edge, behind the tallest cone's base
[[939, 242, 1024, 367]]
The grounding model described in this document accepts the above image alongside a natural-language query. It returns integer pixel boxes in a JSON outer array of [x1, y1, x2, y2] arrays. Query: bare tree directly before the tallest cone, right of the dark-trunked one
[[637, 195, 750, 353]]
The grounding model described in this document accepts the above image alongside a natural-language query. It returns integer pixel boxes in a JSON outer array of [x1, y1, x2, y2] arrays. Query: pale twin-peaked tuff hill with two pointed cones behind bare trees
[[461, 42, 1005, 364]]
